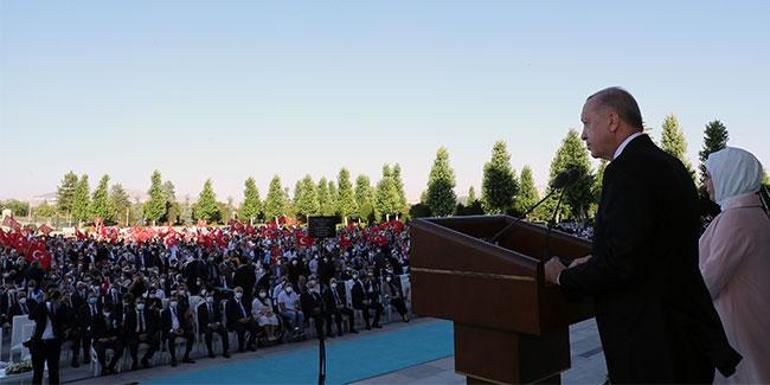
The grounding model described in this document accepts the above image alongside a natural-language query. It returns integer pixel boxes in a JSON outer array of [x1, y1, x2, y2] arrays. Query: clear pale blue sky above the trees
[[0, 0, 770, 200]]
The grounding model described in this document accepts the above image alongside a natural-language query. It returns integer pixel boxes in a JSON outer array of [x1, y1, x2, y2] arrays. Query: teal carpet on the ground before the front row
[[145, 320, 454, 385]]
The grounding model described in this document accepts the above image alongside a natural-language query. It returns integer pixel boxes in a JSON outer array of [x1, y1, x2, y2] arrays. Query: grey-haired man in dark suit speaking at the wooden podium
[[545, 88, 740, 383]]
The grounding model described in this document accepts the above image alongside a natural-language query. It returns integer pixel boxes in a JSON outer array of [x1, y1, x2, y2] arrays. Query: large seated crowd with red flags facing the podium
[[0, 221, 410, 375]]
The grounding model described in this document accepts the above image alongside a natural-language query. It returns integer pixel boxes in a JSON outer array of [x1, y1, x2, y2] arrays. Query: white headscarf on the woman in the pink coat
[[706, 147, 763, 210]]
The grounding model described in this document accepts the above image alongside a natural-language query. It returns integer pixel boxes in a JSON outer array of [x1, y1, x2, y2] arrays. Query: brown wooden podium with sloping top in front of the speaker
[[410, 216, 593, 384]]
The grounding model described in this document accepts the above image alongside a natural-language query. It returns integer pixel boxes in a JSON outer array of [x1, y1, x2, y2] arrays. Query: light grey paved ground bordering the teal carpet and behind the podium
[[0, 318, 606, 385]]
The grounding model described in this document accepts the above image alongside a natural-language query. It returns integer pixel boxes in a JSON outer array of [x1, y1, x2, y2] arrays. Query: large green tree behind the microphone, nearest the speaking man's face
[[547, 129, 594, 220]]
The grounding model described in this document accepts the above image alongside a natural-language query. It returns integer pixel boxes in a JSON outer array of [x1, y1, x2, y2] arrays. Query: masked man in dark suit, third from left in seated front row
[[161, 295, 195, 366]]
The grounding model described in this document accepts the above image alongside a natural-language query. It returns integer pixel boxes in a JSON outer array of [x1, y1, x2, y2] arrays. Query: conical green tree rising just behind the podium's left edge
[[426, 147, 457, 217]]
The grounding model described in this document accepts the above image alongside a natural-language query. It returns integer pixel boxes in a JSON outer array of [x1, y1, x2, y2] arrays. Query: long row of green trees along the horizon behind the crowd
[[45, 115, 770, 225]]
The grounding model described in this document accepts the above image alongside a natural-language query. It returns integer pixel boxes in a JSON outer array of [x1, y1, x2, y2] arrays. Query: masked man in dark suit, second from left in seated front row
[[123, 297, 160, 370]]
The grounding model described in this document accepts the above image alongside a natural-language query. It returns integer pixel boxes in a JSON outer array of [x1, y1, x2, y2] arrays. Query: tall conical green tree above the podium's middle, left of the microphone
[[481, 140, 518, 214]]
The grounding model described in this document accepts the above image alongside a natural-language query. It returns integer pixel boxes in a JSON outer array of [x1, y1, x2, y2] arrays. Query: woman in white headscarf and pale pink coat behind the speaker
[[700, 147, 770, 384]]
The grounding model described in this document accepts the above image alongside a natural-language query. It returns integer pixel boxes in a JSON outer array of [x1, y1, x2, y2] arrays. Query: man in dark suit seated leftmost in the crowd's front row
[[93, 304, 124, 376]]
